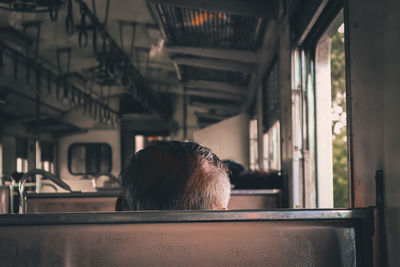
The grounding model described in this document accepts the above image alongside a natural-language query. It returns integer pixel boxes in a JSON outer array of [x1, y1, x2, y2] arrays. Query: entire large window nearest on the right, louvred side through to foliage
[[292, 6, 348, 208]]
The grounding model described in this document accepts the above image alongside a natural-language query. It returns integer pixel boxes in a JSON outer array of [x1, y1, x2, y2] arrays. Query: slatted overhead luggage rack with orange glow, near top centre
[[150, 4, 266, 50]]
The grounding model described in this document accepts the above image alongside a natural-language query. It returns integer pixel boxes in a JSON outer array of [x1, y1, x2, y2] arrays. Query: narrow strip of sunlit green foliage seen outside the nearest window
[[331, 25, 348, 208]]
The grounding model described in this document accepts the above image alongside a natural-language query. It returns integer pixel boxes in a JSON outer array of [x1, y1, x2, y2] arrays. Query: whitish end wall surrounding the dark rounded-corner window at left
[[58, 129, 121, 191]]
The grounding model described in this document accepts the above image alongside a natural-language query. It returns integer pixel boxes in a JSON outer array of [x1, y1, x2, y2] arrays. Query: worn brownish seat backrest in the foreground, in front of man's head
[[0, 209, 373, 267]]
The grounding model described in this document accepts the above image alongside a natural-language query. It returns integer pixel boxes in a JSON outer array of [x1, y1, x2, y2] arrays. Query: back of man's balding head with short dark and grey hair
[[117, 141, 230, 210]]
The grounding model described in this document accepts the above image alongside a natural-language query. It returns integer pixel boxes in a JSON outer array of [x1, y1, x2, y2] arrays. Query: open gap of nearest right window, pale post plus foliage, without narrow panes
[[315, 12, 348, 207]]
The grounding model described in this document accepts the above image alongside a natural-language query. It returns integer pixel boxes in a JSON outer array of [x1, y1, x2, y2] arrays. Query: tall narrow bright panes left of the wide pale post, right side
[[292, 49, 317, 208]]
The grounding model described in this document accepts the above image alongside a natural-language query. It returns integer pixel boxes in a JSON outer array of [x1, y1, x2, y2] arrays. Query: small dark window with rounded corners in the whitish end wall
[[68, 143, 112, 175]]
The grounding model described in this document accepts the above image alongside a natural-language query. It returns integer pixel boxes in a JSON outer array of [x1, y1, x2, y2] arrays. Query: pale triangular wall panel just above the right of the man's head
[[193, 114, 249, 168]]
